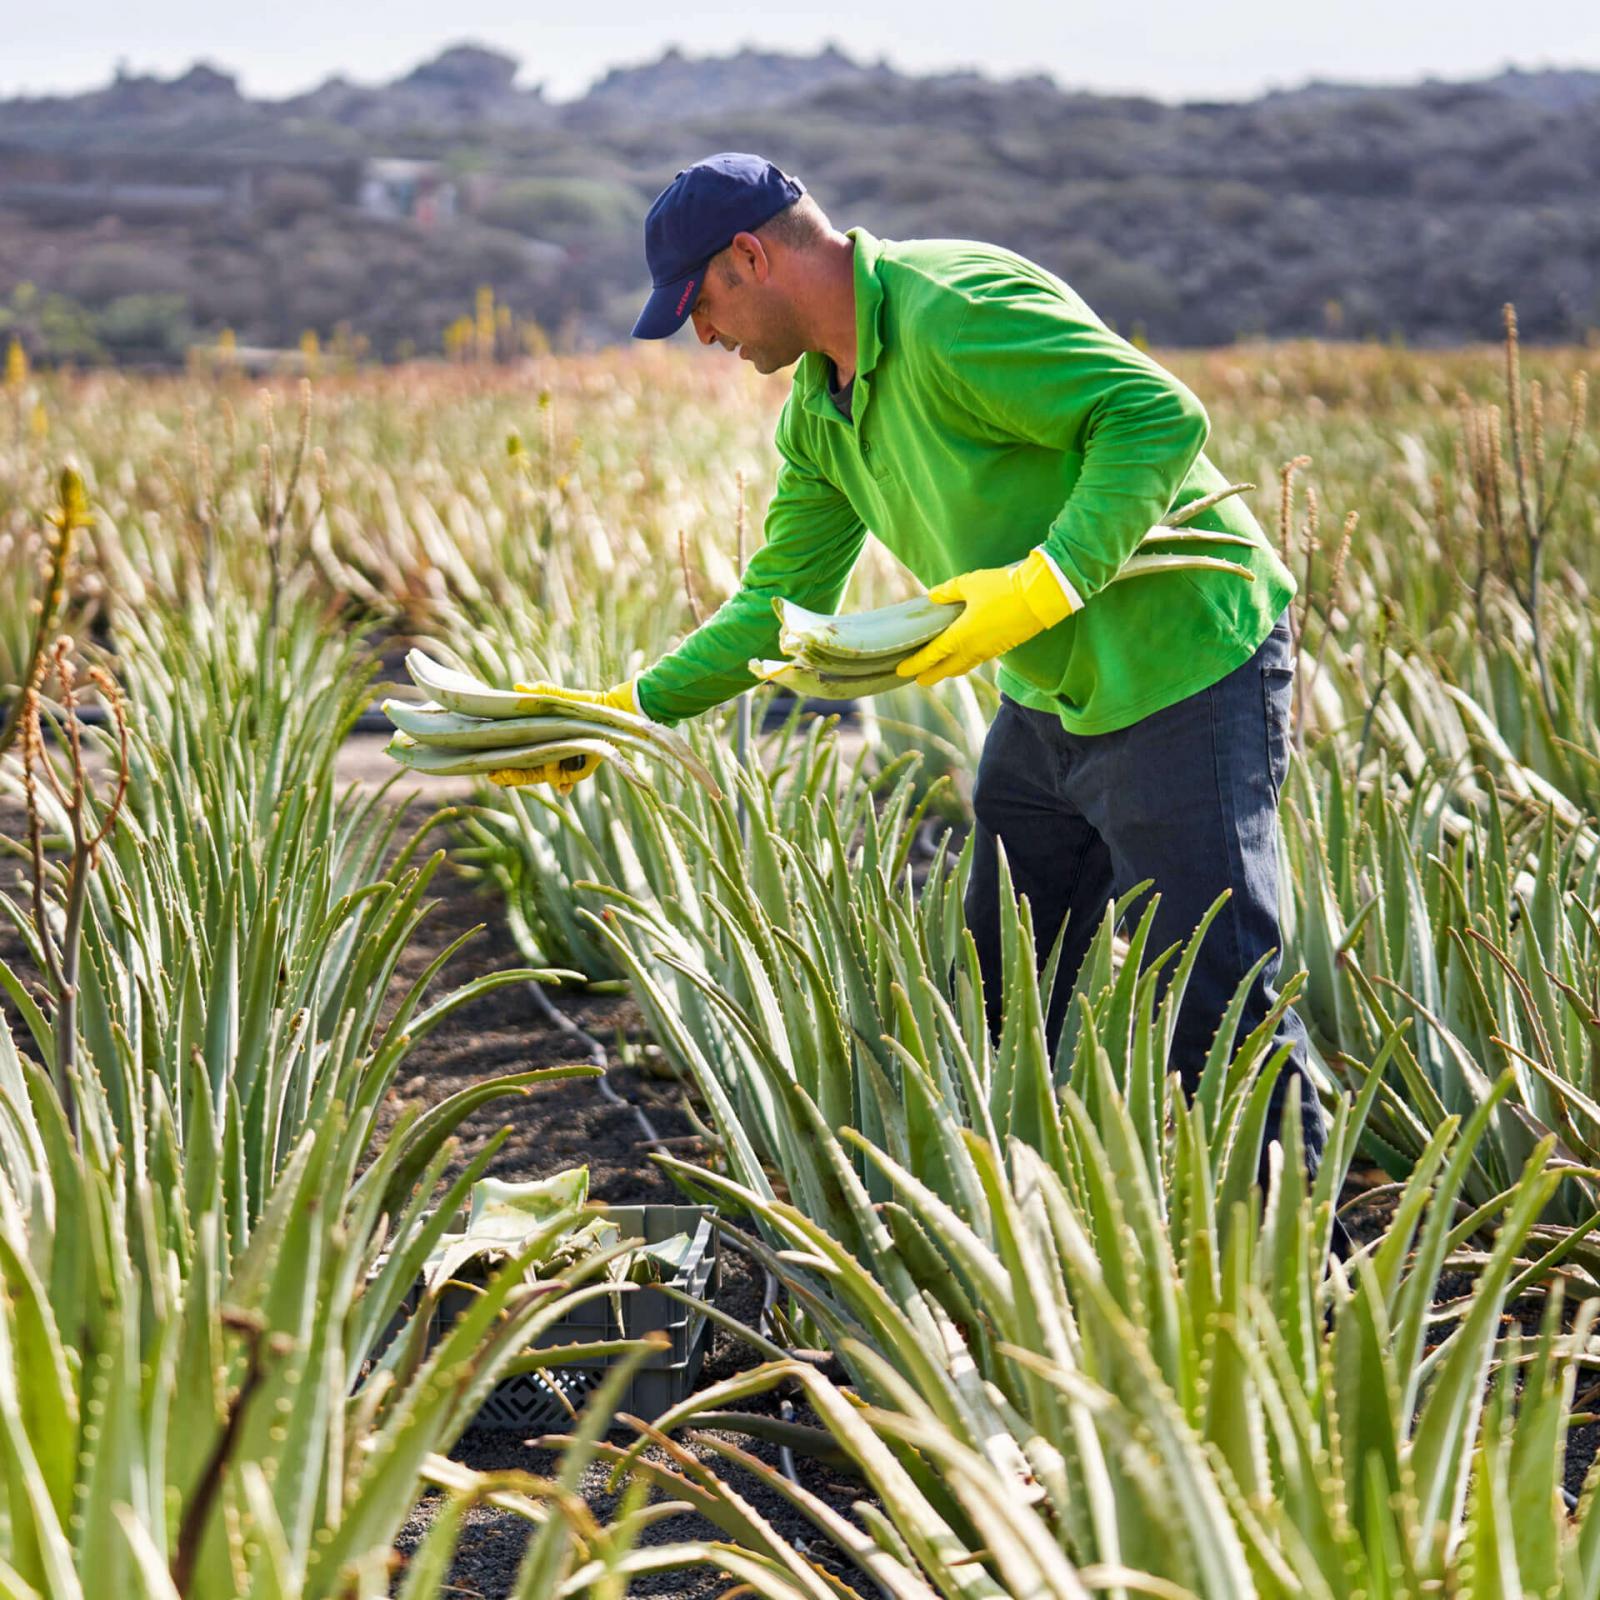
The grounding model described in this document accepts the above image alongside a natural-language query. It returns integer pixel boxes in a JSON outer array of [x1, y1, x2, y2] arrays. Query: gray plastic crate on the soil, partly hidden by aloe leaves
[[403, 1205, 718, 1432]]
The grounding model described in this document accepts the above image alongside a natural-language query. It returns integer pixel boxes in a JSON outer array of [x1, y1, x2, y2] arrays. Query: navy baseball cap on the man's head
[[634, 150, 805, 339]]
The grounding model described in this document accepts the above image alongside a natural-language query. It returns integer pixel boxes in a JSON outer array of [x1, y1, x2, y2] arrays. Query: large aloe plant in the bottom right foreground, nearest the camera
[[614, 1074, 1600, 1600]]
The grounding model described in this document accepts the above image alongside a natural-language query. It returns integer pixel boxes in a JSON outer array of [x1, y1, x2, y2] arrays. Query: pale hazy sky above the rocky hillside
[[0, 0, 1600, 99]]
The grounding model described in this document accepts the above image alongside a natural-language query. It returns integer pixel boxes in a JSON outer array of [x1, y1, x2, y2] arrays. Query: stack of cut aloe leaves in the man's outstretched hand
[[382, 650, 720, 795]]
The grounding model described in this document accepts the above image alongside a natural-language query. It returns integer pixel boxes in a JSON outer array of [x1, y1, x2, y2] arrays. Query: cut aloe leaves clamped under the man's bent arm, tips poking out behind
[[750, 483, 1259, 699]]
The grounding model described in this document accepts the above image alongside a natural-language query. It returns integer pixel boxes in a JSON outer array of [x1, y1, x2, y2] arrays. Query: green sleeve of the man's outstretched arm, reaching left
[[638, 413, 867, 726]]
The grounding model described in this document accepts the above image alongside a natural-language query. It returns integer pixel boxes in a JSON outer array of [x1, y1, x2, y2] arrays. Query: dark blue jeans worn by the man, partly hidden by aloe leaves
[[966, 614, 1325, 1173]]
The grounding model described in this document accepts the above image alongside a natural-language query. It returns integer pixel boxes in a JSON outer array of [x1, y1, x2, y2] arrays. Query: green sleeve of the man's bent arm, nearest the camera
[[947, 275, 1210, 603]]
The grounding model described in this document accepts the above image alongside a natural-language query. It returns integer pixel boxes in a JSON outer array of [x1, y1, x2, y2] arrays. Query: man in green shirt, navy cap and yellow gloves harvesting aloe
[[504, 154, 1323, 1165]]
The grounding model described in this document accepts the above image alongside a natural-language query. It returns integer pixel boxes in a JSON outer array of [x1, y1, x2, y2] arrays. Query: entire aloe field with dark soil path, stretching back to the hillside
[[0, 320, 1600, 1600]]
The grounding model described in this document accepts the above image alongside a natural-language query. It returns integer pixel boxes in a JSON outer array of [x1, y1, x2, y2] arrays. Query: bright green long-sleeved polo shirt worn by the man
[[638, 229, 1294, 733]]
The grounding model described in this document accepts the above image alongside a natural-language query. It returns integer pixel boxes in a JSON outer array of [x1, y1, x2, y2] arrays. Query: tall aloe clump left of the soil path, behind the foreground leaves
[[0, 601, 588, 1246]]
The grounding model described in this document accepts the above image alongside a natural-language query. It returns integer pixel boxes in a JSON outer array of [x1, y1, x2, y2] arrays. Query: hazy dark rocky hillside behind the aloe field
[[0, 45, 1600, 358]]
